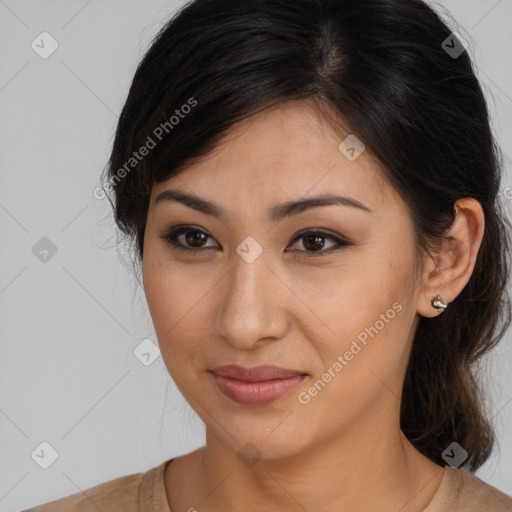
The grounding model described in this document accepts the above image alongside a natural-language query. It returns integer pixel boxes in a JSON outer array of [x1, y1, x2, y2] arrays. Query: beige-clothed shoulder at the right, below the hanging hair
[[425, 466, 512, 512]]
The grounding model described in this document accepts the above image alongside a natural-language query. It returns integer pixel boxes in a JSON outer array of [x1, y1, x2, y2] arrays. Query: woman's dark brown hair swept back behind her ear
[[103, 0, 511, 470]]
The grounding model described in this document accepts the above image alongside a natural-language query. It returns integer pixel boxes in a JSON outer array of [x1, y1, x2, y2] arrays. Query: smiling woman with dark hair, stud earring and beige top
[[26, 0, 512, 512]]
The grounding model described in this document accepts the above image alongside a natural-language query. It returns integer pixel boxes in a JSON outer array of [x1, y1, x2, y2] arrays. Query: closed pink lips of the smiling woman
[[211, 365, 306, 405]]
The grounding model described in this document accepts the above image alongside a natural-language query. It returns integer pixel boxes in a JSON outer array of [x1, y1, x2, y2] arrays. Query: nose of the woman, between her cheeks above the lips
[[214, 252, 293, 350]]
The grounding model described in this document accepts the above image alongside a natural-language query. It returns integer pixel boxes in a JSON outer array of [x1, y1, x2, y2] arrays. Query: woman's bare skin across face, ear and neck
[[143, 102, 484, 512]]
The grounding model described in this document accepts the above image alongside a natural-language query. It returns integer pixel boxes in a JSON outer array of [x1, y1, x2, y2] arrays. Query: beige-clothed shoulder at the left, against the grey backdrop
[[21, 463, 165, 512]]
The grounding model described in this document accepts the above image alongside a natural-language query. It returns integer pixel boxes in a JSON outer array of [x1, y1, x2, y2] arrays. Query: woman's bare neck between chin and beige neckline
[[195, 418, 444, 512]]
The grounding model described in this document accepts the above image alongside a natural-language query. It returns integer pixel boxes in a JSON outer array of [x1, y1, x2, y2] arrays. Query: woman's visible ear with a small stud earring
[[417, 198, 485, 317]]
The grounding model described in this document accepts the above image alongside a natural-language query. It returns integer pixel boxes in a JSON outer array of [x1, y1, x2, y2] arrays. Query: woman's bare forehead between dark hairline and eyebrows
[[152, 102, 396, 213]]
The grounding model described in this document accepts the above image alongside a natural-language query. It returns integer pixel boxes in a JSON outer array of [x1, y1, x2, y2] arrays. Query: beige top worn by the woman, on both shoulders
[[22, 459, 512, 512]]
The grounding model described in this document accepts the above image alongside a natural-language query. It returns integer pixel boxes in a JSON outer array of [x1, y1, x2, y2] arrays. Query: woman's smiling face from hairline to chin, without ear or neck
[[143, 103, 421, 459]]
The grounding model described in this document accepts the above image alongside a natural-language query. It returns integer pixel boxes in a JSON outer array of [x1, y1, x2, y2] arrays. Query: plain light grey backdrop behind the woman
[[0, 0, 512, 512]]
